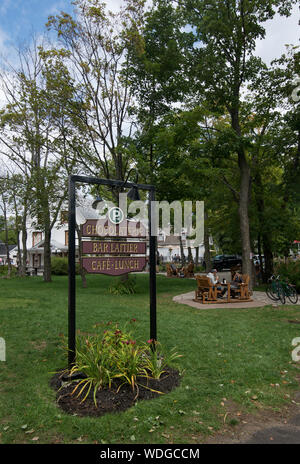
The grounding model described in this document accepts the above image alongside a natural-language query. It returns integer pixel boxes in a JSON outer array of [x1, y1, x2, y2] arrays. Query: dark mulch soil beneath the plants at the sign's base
[[50, 368, 180, 417]]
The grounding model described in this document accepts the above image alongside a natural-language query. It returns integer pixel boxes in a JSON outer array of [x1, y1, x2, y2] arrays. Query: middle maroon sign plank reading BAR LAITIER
[[81, 240, 146, 255]]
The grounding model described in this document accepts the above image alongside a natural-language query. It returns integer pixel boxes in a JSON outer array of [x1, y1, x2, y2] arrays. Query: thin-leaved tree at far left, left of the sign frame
[[0, 38, 74, 282]]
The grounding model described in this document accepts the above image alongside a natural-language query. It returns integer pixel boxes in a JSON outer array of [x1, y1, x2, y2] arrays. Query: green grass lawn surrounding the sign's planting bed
[[0, 274, 300, 444]]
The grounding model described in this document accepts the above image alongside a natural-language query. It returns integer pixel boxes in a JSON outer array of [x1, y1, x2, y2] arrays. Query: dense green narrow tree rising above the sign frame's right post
[[125, 0, 194, 183]]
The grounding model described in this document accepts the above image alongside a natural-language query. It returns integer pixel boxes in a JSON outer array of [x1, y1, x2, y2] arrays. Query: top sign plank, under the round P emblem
[[81, 219, 146, 238]]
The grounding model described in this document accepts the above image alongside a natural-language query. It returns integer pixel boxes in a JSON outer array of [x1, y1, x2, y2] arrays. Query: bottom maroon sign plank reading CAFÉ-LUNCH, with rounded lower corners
[[82, 256, 146, 276]]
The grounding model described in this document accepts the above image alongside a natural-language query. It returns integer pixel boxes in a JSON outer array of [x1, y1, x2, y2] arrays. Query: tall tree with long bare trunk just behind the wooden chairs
[[177, 0, 295, 282]]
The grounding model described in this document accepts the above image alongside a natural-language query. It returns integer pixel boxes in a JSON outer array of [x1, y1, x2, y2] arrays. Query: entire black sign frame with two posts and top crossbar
[[68, 175, 157, 369]]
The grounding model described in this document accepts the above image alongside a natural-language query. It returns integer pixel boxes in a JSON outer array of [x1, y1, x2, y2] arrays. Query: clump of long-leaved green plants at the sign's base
[[66, 323, 179, 406]]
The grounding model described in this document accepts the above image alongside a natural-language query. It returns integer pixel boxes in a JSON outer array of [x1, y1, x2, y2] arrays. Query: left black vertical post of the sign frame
[[68, 176, 76, 369]]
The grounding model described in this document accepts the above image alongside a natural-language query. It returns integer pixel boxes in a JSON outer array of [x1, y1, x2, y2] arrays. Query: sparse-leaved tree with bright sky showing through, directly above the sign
[[48, 0, 143, 200]]
